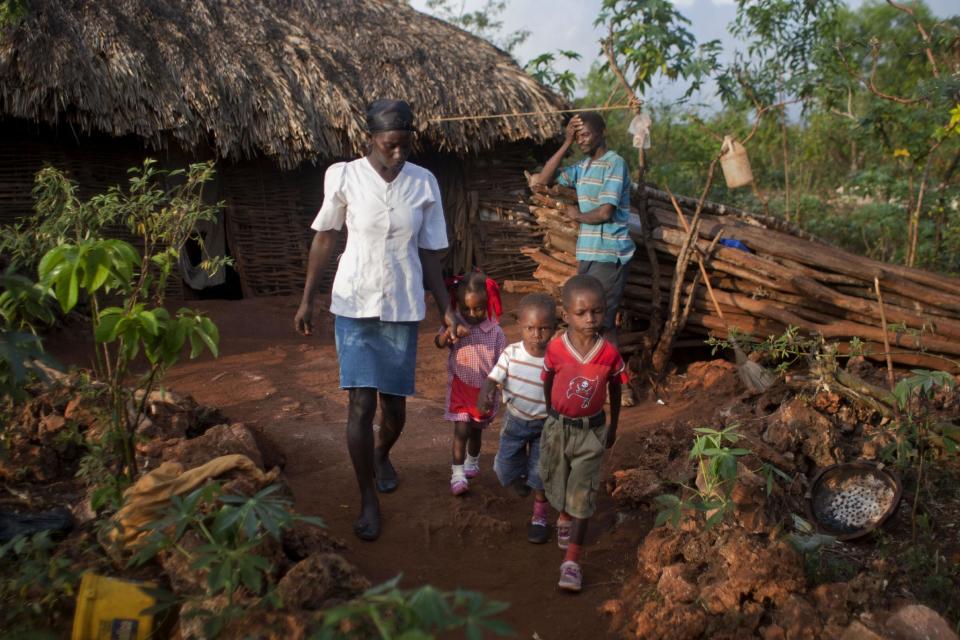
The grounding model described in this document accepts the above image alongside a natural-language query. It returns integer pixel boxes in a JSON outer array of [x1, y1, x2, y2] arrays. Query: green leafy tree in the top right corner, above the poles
[[818, 0, 960, 266]]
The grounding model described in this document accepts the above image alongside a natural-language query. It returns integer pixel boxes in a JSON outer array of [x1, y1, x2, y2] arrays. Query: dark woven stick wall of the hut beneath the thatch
[[0, 131, 543, 300]]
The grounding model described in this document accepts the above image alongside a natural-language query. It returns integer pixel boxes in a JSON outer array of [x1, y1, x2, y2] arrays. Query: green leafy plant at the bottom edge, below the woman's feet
[[311, 576, 513, 640]]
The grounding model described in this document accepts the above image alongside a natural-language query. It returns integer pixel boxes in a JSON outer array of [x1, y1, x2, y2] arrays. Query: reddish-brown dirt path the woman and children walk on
[[48, 296, 715, 640]]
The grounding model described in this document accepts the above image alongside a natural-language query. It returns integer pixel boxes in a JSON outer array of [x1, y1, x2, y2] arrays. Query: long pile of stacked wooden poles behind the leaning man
[[515, 181, 960, 373]]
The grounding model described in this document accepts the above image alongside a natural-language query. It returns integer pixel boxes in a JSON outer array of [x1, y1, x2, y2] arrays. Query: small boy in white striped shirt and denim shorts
[[477, 293, 557, 544]]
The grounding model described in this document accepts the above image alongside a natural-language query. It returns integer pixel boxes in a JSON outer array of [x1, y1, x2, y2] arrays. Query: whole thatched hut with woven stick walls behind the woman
[[0, 0, 561, 295]]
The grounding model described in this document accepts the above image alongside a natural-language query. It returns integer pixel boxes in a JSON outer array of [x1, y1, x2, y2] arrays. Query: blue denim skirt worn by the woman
[[334, 316, 420, 396]]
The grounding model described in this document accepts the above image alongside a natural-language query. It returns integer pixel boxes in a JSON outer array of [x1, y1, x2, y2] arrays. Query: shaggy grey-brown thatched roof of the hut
[[0, 0, 561, 167]]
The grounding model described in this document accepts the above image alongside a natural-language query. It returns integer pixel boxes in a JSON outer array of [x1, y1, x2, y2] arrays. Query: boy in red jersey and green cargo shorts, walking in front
[[540, 275, 627, 592]]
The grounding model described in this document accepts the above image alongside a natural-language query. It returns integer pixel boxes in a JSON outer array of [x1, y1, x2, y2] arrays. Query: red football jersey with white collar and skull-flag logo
[[541, 332, 627, 418]]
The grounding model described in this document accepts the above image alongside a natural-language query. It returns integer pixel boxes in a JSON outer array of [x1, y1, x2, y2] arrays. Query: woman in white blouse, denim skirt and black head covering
[[294, 100, 463, 540]]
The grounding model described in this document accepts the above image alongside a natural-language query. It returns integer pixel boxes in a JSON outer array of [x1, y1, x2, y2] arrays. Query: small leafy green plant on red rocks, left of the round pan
[[654, 424, 750, 530]]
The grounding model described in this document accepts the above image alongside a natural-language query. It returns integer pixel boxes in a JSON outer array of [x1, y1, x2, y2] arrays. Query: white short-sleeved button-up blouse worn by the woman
[[310, 158, 447, 322]]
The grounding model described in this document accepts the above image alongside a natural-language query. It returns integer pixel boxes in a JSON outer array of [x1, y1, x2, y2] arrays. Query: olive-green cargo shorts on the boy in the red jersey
[[540, 415, 607, 519]]
